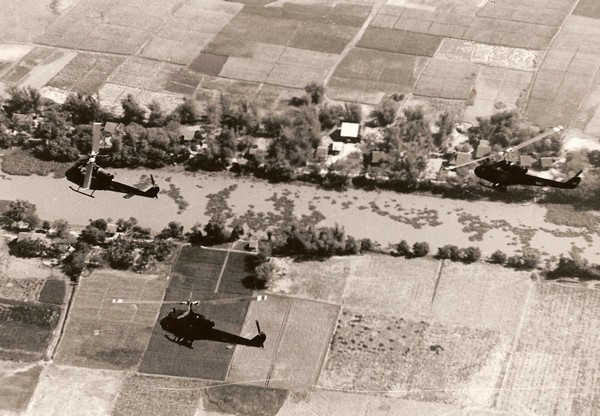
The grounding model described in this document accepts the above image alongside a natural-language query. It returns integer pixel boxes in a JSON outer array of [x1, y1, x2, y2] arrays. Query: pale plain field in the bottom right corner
[[498, 284, 600, 415]]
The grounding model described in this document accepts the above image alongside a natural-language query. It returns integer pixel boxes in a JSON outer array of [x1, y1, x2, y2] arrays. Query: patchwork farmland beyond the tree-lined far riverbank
[[0, 0, 600, 127]]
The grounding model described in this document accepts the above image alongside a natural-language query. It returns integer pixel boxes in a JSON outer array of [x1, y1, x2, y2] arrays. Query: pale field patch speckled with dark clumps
[[320, 310, 509, 404]]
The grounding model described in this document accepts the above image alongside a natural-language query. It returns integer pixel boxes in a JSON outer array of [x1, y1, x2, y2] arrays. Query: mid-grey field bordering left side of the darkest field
[[55, 270, 167, 370]]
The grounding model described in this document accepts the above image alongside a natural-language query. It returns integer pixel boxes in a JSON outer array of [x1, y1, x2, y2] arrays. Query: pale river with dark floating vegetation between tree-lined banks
[[0, 169, 600, 262]]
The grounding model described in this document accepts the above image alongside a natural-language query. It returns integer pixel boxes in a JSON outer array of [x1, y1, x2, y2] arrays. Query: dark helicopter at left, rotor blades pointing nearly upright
[[65, 123, 160, 198]]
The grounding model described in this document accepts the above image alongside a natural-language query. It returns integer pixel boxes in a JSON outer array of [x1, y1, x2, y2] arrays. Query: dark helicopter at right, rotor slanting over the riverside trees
[[446, 126, 582, 192]]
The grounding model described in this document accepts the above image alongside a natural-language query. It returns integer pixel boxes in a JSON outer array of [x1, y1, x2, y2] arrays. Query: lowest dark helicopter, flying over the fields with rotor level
[[112, 294, 267, 349]]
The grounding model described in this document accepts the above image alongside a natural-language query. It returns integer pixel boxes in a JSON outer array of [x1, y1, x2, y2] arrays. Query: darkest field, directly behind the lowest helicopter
[[140, 246, 256, 380]]
